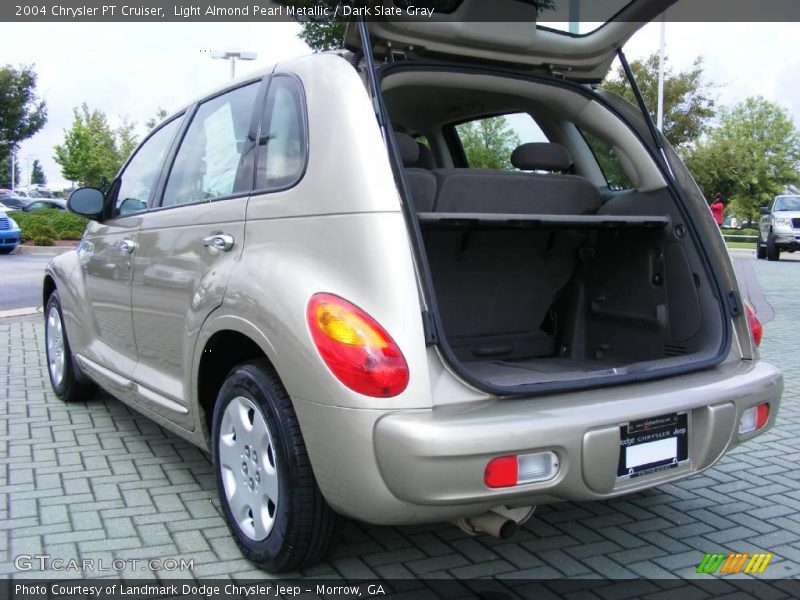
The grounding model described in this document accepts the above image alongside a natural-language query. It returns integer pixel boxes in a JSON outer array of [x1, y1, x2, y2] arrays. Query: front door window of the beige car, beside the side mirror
[[116, 117, 183, 216]]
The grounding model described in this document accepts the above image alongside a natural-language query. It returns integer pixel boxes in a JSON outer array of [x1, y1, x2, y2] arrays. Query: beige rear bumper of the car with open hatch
[[296, 361, 783, 524]]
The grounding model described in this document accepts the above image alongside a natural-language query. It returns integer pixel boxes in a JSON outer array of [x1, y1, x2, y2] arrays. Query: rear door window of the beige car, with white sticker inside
[[161, 82, 259, 206]]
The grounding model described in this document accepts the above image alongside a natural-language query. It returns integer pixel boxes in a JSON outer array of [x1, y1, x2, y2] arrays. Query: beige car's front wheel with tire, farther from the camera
[[44, 291, 97, 402]]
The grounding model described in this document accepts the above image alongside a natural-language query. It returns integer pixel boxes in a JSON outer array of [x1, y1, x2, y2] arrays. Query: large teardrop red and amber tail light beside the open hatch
[[306, 294, 408, 398]]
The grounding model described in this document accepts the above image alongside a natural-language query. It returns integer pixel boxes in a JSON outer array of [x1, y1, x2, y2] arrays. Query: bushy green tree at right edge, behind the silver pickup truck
[[686, 96, 800, 220]]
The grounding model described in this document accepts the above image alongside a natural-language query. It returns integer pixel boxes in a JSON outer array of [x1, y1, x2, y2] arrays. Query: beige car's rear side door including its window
[[132, 80, 266, 427]]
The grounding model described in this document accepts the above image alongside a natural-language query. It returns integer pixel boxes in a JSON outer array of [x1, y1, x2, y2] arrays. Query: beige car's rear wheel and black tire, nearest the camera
[[212, 360, 338, 573]]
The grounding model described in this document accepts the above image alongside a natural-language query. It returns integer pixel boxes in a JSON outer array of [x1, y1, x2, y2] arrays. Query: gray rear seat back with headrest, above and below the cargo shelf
[[425, 146, 601, 361]]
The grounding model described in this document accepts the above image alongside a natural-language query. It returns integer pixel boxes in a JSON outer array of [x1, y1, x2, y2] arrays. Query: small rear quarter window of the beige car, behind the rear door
[[256, 76, 306, 190]]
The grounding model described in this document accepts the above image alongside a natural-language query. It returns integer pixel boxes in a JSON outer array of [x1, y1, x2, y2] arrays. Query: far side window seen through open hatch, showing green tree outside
[[455, 113, 547, 171]]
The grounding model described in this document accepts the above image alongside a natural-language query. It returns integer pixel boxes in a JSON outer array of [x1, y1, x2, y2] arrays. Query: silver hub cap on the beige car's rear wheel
[[219, 396, 279, 541]]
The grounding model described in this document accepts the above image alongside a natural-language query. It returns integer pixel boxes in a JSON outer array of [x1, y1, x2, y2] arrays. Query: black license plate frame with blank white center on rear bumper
[[617, 412, 689, 479]]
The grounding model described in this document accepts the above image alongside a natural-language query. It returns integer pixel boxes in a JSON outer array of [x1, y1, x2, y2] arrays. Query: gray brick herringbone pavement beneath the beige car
[[0, 253, 800, 578]]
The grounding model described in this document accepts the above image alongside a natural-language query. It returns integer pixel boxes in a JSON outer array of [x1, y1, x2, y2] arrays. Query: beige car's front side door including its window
[[78, 117, 181, 386]]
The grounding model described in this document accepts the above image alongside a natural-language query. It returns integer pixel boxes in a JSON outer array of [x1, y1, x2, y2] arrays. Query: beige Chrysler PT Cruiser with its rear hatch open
[[44, 0, 783, 571]]
